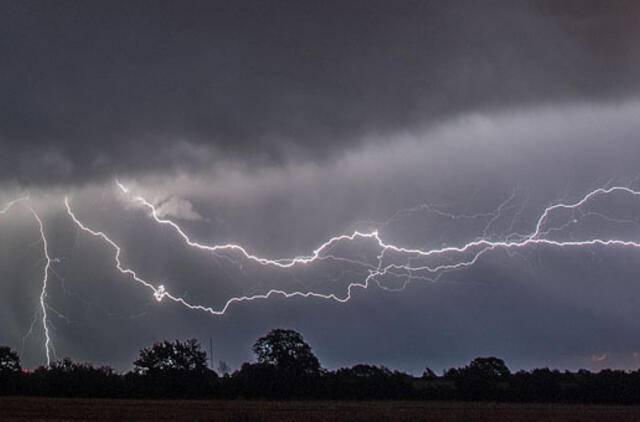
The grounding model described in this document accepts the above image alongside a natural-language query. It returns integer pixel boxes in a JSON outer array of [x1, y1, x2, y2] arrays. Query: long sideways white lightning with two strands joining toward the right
[[60, 181, 640, 315]]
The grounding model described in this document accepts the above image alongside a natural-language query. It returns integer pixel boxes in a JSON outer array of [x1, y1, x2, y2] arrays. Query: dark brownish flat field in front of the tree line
[[0, 397, 640, 422]]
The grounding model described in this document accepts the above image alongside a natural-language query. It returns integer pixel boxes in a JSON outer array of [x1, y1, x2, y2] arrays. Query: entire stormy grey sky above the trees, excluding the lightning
[[0, 0, 640, 373]]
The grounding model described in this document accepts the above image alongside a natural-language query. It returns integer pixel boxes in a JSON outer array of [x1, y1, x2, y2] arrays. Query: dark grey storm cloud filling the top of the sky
[[0, 1, 640, 183]]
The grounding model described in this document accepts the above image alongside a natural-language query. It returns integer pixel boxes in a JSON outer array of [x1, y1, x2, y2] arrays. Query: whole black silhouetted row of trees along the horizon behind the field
[[0, 329, 640, 404]]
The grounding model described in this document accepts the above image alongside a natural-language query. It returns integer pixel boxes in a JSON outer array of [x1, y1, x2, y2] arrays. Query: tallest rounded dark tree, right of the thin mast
[[252, 328, 320, 375]]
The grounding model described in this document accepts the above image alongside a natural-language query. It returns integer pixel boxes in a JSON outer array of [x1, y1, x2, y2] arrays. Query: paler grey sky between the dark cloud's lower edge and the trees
[[5, 102, 640, 373]]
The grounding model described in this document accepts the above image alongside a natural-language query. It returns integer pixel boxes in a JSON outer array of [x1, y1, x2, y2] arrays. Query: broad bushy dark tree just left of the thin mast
[[133, 339, 207, 374]]
